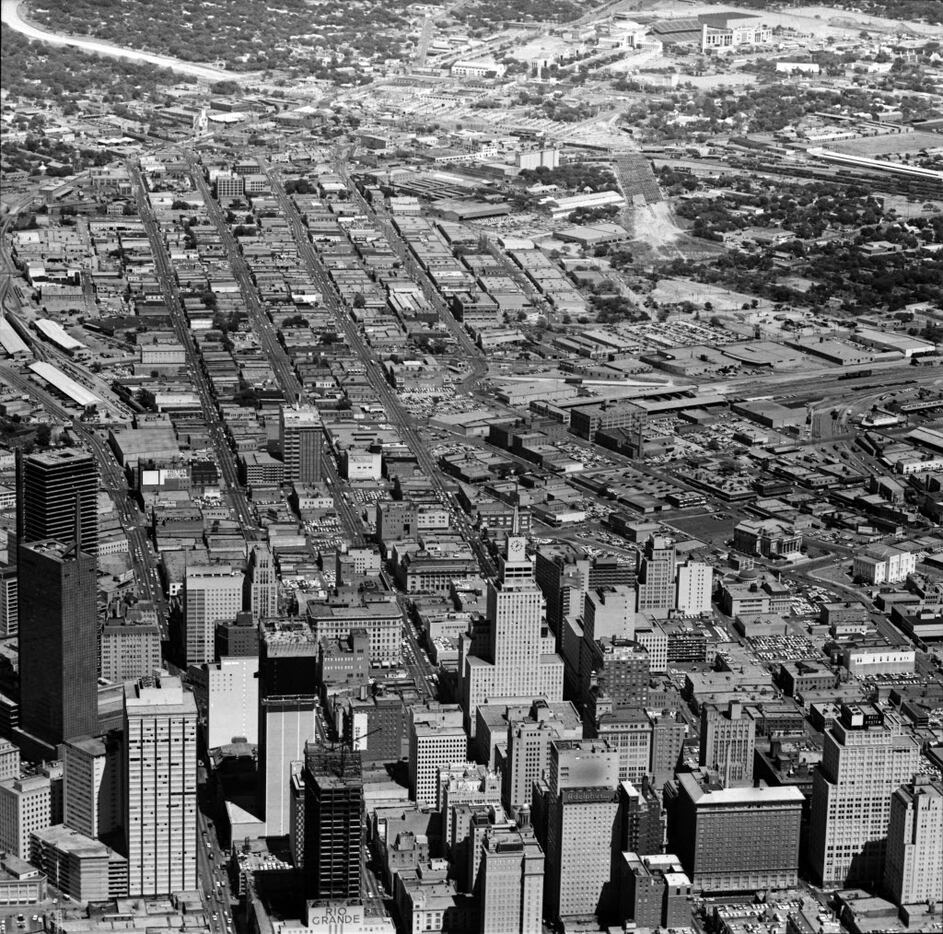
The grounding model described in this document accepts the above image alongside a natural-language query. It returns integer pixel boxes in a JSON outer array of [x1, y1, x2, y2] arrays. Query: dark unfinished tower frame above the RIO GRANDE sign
[[303, 743, 363, 901]]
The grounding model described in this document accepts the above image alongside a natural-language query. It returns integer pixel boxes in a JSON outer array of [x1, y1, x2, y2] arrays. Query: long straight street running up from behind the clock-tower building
[[265, 168, 496, 577]]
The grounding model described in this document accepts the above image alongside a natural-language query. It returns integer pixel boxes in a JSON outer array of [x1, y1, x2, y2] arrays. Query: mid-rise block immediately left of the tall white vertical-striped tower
[[61, 734, 123, 838]]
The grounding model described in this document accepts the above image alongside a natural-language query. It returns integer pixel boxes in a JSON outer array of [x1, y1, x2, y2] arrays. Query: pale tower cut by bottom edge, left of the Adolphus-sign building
[[476, 828, 544, 934]]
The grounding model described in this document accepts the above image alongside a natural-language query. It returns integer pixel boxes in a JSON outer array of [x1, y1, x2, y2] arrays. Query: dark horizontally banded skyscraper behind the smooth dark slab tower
[[17, 448, 98, 558]]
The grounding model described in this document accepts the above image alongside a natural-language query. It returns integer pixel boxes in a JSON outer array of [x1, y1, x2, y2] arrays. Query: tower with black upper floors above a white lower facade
[[258, 621, 318, 837]]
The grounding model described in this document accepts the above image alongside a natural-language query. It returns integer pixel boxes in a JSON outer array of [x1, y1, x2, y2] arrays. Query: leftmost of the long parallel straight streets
[[128, 163, 257, 536]]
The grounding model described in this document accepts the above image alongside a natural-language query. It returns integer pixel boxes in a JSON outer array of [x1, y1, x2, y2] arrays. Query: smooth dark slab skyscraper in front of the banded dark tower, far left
[[19, 540, 98, 745]]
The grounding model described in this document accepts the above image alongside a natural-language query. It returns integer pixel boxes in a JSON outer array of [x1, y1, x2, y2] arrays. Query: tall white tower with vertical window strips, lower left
[[123, 678, 198, 895]]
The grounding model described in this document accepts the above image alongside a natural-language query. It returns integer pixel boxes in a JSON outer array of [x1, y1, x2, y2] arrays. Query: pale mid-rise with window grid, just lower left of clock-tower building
[[408, 701, 468, 807]]
